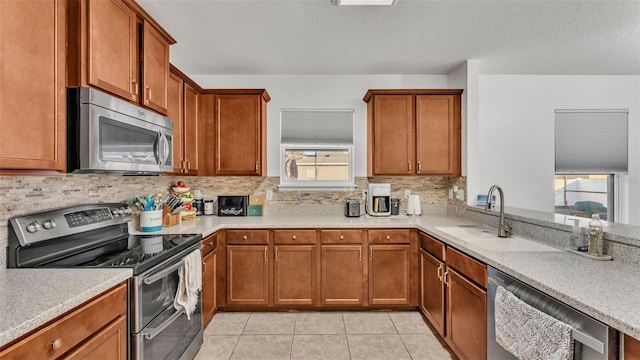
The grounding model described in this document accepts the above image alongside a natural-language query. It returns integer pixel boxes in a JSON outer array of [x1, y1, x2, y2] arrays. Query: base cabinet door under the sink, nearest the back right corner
[[420, 249, 445, 337]]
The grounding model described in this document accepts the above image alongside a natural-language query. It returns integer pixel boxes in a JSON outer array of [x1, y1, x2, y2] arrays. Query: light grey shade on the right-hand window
[[555, 110, 629, 174]]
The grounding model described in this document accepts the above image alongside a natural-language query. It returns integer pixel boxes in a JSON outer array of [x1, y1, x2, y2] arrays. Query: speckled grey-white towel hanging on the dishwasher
[[495, 286, 573, 360]]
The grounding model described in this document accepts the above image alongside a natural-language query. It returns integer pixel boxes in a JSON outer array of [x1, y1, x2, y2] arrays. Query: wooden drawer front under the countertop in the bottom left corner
[[0, 284, 127, 359]]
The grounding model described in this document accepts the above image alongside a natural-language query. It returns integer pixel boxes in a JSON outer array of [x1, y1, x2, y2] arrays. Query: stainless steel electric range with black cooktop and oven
[[7, 203, 203, 360]]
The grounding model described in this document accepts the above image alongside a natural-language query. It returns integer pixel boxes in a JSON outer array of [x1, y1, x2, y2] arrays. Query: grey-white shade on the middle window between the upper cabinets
[[280, 109, 353, 144]]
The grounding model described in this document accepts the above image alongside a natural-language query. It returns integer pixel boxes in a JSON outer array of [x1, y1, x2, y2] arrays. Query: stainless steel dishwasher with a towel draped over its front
[[487, 266, 616, 360]]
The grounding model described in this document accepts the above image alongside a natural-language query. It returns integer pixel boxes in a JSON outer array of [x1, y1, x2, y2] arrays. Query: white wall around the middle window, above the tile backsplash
[[190, 75, 447, 176]]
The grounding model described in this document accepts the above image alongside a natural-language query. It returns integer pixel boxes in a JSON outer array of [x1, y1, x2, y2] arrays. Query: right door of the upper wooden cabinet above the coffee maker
[[416, 95, 456, 175]]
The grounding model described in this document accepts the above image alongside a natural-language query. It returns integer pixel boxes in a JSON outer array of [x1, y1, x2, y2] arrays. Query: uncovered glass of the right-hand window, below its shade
[[555, 174, 615, 221]]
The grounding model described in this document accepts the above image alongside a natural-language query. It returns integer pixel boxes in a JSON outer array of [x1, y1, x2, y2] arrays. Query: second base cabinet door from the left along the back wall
[[273, 245, 316, 305]]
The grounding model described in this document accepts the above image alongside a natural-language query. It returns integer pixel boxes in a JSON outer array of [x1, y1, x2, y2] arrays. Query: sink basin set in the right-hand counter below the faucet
[[436, 225, 562, 251]]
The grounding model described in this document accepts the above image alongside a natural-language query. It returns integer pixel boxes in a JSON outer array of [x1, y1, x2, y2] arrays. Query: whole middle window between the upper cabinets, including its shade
[[280, 109, 355, 190]]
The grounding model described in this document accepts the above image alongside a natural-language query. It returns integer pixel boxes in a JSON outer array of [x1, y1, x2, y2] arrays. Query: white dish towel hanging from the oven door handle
[[173, 249, 202, 320]]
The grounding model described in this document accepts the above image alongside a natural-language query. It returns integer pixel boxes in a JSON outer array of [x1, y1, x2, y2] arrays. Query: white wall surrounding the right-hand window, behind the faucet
[[467, 75, 640, 225]]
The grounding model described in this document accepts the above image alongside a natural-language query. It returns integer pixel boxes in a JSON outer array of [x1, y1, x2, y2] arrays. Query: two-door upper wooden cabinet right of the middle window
[[364, 89, 462, 176]]
